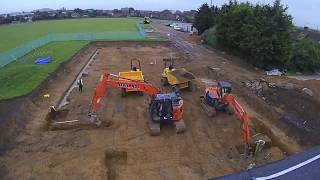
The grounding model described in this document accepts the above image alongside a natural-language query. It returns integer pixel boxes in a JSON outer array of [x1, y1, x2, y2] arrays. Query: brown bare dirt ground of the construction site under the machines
[[0, 25, 319, 179]]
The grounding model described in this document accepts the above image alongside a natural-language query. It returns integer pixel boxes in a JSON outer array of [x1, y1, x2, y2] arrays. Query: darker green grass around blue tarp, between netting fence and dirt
[[0, 41, 88, 100]]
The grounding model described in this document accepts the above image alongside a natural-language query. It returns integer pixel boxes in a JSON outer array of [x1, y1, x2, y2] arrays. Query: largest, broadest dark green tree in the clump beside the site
[[216, 0, 293, 68]]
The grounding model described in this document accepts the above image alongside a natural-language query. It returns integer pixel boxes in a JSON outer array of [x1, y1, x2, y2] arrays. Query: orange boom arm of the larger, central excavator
[[91, 73, 160, 113]]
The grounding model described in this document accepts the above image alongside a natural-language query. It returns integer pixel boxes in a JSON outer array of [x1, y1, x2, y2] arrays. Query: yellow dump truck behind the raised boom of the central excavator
[[119, 59, 144, 97]]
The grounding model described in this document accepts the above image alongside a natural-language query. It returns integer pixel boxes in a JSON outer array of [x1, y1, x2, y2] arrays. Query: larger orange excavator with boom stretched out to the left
[[89, 73, 186, 135]]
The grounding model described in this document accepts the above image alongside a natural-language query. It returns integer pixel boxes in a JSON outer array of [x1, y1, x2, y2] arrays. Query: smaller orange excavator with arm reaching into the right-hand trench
[[201, 81, 250, 149]]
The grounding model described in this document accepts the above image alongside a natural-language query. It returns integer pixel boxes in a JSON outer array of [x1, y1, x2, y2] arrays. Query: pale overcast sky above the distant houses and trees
[[0, 0, 320, 28]]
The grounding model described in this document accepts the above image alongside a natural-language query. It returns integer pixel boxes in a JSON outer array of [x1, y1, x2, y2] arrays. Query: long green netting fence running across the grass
[[0, 21, 146, 67]]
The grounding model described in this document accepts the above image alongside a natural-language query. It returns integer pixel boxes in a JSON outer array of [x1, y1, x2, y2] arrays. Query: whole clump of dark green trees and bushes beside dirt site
[[199, 0, 320, 72]]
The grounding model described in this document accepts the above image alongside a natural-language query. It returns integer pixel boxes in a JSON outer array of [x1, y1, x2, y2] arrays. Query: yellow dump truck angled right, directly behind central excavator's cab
[[161, 59, 195, 91]]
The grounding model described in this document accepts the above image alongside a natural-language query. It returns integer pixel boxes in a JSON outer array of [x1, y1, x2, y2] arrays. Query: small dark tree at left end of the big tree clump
[[193, 3, 214, 34]]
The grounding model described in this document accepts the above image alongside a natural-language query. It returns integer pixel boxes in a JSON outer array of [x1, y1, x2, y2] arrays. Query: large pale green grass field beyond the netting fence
[[0, 18, 138, 53]]
